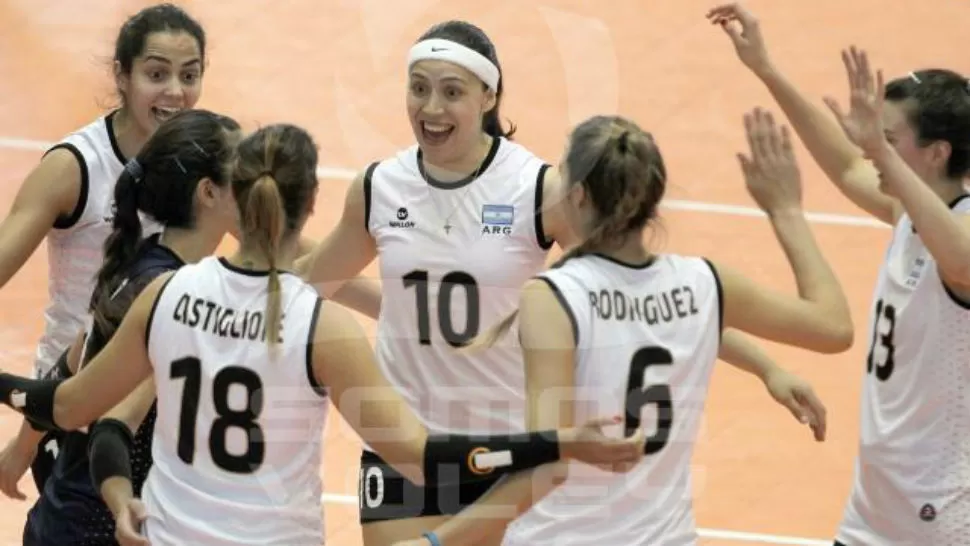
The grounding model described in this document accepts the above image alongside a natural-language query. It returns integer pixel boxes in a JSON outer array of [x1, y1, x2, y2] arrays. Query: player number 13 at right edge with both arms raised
[[710, 5, 970, 546]]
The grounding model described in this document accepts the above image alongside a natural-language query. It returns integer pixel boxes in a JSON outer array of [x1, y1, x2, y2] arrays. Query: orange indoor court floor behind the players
[[0, 0, 970, 546]]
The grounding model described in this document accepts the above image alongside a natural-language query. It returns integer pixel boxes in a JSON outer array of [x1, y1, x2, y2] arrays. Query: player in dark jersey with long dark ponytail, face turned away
[[24, 110, 239, 546]]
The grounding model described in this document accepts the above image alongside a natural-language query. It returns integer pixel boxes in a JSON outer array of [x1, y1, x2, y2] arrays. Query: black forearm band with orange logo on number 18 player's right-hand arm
[[424, 430, 559, 485]]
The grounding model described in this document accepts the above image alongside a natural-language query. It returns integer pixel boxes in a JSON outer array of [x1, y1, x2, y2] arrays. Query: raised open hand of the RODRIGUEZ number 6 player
[[738, 108, 802, 217]]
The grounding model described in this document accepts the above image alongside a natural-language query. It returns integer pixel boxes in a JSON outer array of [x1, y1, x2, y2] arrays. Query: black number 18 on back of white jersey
[[170, 357, 266, 474]]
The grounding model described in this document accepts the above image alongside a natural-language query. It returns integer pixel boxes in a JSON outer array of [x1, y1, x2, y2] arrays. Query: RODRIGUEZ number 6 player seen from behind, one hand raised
[[392, 110, 852, 546]]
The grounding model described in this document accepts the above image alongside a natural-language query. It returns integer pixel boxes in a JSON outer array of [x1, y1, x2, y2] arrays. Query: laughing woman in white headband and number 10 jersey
[[308, 17, 824, 546]]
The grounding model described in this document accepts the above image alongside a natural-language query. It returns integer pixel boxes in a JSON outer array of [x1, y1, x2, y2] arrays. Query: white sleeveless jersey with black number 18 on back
[[142, 257, 329, 546]]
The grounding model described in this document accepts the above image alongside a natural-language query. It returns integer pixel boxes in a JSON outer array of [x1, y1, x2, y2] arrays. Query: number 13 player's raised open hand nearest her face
[[825, 46, 886, 152]]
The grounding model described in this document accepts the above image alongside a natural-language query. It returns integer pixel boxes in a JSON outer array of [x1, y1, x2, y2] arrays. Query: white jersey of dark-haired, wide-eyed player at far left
[[34, 112, 159, 376]]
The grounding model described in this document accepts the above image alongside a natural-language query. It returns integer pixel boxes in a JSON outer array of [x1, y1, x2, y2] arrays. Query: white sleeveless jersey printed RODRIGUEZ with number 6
[[503, 254, 722, 546]]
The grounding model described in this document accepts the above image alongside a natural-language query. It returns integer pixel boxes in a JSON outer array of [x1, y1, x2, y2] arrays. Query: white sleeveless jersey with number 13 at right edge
[[838, 196, 970, 546]]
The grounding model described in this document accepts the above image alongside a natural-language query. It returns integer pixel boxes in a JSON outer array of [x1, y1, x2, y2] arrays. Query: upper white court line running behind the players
[[0, 137, 889, 229]]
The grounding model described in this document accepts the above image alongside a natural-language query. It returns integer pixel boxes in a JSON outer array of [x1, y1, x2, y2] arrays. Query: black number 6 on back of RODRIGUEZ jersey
[[623, 347, 674, 455]]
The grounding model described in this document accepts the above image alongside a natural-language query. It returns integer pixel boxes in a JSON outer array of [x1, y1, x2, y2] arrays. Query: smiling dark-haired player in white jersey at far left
[[0, 4, 206, 492]]
